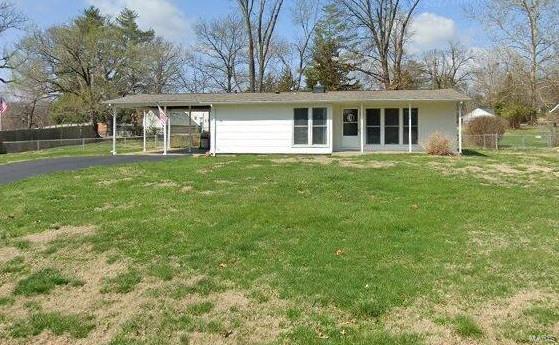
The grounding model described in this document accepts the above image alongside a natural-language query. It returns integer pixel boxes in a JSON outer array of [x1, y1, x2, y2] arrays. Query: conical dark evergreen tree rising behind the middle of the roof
[[305, 5, 361, 91]]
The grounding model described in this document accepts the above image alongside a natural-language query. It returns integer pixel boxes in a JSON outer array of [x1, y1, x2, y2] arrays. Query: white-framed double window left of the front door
[[293, 108, 328, 145]]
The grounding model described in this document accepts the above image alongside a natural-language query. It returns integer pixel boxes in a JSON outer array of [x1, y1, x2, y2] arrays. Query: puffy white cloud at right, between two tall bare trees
[[410, 12, 458, 53]]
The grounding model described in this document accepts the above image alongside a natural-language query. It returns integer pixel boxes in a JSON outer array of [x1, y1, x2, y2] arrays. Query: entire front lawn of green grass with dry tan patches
[[0, 153, 559, 344]]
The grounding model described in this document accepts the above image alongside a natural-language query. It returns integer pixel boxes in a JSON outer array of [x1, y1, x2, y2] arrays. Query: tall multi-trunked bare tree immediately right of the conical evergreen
[[338, 0, 421, 89]]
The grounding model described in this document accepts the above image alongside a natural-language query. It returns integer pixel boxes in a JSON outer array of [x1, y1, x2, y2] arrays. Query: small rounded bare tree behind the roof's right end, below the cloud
[[423, 42, 473, 89]]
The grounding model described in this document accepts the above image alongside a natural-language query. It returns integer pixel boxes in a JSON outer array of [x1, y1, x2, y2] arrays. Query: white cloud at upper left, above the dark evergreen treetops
[[87, 0, 192, 43]]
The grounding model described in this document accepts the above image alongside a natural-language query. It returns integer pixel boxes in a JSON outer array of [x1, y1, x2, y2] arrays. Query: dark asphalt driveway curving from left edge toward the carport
[[0, 155, 181, 185]]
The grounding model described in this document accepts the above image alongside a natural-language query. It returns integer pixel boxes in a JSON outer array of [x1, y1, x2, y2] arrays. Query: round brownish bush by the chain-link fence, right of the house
[[465, 116, 507, 147]]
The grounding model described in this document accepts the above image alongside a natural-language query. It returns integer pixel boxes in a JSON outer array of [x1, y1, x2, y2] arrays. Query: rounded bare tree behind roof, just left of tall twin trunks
[[196, 16, 246, 92]]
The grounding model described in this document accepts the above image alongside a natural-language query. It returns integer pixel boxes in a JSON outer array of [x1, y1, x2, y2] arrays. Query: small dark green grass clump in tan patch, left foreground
[[14, 268, 82, 296]]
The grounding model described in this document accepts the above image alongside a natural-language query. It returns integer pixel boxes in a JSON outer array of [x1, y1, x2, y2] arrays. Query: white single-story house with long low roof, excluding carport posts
[[105, 89, 470, 154]]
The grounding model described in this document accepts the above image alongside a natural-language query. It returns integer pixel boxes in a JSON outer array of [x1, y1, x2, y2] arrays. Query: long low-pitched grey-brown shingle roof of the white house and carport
[[103, 89, 470, 108]]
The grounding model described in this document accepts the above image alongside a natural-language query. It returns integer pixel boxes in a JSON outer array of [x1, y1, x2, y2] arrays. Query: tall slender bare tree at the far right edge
[[470, 0, 559, 108]]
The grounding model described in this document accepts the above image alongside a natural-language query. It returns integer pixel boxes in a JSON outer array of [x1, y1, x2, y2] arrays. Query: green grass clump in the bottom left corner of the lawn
[[10, 313, 95, 338]]
